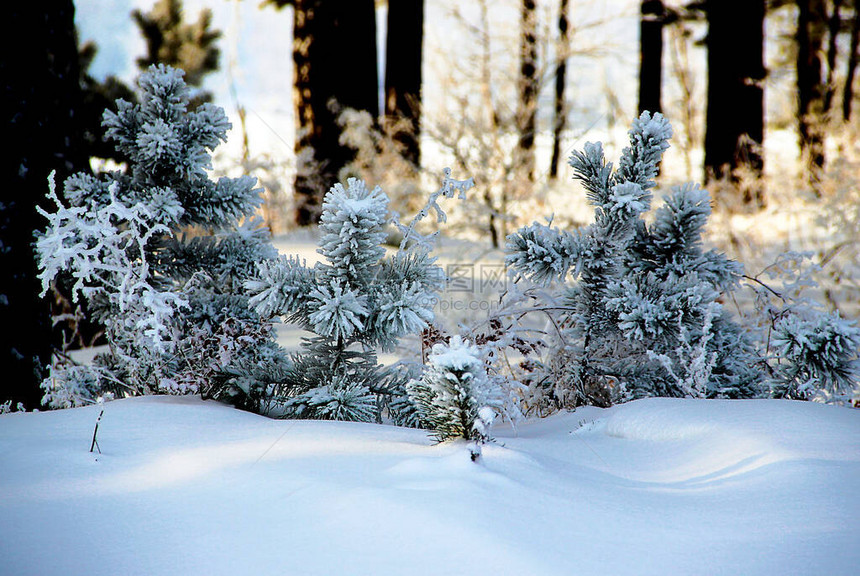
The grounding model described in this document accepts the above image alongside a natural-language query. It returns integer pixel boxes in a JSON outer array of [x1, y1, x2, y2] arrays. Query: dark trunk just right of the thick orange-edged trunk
[[385, 0, 424, 169]]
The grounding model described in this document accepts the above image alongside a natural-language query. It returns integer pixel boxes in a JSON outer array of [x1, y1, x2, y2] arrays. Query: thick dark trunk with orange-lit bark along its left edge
[[293, 0, 379, 226]]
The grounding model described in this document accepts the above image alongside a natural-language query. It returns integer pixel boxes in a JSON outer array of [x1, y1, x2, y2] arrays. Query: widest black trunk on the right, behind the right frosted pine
[[704, 0, 765, 206]]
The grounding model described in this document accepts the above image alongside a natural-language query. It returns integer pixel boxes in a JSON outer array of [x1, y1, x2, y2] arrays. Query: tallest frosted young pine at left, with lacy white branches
[[38, 65, 277, 407]]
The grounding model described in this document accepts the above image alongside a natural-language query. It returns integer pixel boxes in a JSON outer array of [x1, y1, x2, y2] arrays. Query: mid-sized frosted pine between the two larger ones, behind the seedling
[[245, 171, 473, 422]]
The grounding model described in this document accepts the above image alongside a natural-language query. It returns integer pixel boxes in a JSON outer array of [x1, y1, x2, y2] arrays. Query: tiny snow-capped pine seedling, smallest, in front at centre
[[406, 336, 505, 443]]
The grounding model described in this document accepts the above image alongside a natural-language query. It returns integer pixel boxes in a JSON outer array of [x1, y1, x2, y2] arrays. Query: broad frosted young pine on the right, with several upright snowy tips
[[507, 112, 760, 405]]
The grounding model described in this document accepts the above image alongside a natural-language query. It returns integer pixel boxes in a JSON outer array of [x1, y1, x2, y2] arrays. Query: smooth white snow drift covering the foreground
[[0, 396, 860, 576]]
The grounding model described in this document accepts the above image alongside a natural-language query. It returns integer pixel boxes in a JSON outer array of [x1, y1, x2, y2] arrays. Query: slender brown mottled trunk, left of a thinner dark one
[[515, 0, 538, 180]]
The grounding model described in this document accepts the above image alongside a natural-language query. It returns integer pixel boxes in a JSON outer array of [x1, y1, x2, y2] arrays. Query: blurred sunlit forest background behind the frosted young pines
[[5, 0, 860, 407]]
